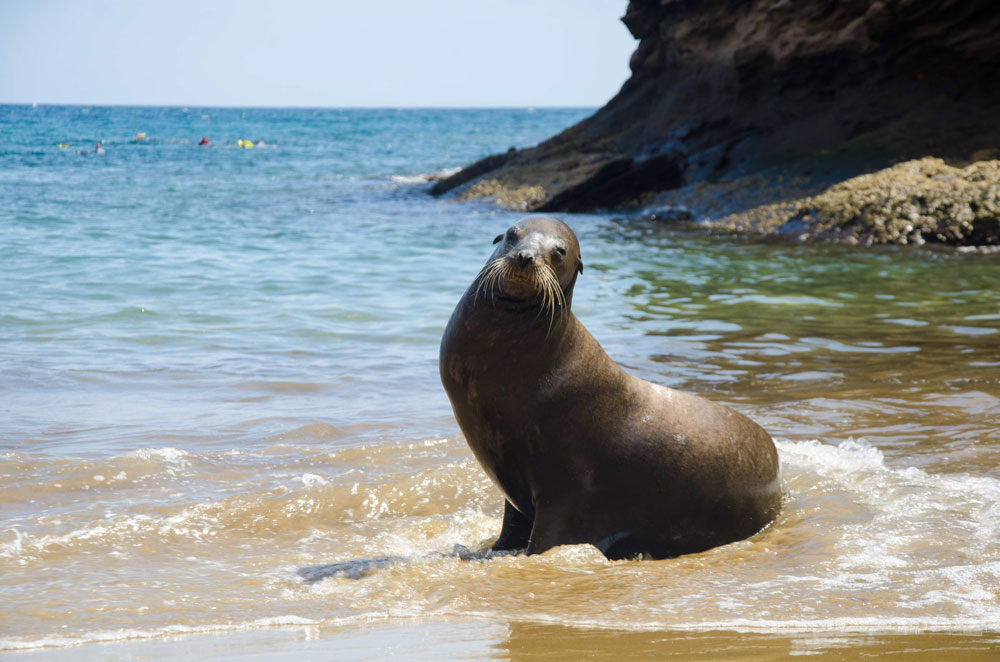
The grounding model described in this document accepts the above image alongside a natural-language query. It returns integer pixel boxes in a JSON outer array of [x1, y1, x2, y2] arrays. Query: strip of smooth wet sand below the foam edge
[[5, 620, 1000, 662]]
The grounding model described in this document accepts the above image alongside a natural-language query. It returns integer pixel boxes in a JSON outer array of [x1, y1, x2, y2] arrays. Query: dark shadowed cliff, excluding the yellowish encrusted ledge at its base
[[432, 0, 1000, 244]]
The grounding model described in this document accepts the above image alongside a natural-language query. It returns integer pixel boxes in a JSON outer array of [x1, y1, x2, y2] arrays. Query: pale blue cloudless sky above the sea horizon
[[0, 0, 636, 107]]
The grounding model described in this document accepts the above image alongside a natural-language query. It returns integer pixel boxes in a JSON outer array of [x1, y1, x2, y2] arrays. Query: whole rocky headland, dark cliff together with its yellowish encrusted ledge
[[429, 0, 1000, 246]]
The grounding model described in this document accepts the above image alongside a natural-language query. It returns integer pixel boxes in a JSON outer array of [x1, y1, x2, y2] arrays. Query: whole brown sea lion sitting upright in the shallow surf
[[440, 217, 781, 559]]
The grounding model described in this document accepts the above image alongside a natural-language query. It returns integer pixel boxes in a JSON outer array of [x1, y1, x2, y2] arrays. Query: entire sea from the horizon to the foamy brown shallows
[[0, 106, 1000, 659]]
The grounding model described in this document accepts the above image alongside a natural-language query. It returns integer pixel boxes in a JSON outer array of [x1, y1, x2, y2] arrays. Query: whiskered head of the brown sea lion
[[476, 216, 583, 316]]
